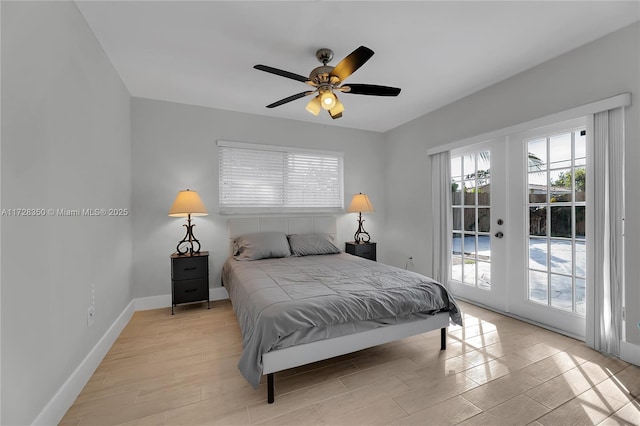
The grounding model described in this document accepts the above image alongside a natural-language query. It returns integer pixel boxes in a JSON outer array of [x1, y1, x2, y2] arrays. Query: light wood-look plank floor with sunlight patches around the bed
[[61, 301, 640, 426]]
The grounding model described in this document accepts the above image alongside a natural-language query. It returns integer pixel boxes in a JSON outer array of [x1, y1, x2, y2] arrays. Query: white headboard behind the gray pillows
[[227, 216, 337, 248]]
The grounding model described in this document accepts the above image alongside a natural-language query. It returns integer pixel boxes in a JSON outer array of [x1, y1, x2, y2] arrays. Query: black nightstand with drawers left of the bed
[[171, 251, 211, 315]]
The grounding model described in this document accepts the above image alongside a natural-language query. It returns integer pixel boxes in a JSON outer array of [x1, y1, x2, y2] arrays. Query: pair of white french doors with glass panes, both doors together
[[450, 120, 589, 338]]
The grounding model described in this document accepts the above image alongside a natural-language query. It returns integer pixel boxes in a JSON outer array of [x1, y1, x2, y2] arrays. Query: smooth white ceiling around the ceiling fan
[[76, 0, 640, 132]]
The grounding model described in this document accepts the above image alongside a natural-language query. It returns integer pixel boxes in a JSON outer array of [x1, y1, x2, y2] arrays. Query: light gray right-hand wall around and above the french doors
[[385, 23, 640, 344]]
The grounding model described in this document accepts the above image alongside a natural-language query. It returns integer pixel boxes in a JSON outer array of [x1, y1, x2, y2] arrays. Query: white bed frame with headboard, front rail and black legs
[[228, 216, 449, 404]]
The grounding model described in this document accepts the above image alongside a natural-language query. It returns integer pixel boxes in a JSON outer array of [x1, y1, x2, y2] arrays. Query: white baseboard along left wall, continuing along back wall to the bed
[[33, 287, 229, 425]]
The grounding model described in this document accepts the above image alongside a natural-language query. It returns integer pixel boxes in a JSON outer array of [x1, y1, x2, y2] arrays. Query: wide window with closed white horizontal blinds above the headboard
[[218, 141, 344, 214]]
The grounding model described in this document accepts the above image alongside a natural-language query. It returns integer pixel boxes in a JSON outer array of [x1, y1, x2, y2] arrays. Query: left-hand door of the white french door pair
[[449, 140, 508, 311]]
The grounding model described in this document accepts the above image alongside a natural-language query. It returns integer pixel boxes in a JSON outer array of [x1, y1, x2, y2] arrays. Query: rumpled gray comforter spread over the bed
[[222, 253, 462, 387]]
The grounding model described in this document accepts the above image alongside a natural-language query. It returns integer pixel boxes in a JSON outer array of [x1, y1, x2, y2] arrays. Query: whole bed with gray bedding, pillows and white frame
[[222, 217, 462, 403]]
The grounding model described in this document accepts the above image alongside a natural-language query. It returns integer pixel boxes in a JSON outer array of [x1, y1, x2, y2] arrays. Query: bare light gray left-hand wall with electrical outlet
[[0, 1, 132, 425]]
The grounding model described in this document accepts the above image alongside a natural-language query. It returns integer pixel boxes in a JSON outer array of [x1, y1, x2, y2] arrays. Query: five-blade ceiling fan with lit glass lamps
[[254, 46, 400, 120]]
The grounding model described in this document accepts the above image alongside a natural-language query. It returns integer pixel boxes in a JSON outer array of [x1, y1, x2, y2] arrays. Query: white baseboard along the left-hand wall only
[[33, 300, 135, 425]]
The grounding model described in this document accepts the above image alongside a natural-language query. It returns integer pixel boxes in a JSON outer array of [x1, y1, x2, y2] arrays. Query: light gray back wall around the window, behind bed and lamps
[[132, 98, 387, 297]]
